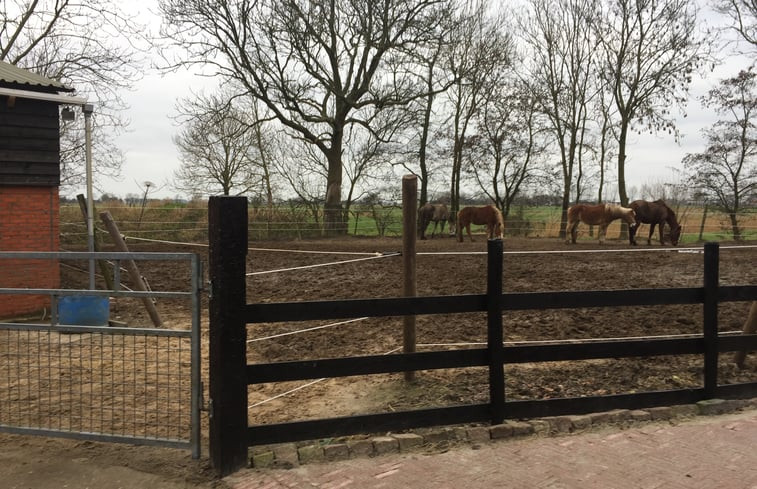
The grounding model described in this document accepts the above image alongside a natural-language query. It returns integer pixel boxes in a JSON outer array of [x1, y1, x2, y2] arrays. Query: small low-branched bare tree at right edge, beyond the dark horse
[[684, 71, 757, 240]]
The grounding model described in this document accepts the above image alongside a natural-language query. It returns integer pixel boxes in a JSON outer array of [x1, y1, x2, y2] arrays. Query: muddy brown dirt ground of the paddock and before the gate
[[0, 235, 757, 489]]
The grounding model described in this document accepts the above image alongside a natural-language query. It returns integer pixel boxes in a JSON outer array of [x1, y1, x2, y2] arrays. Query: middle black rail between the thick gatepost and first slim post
[[247, 348, 488, 385]]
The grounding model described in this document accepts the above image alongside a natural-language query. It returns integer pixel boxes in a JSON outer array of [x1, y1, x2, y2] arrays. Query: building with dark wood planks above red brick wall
[[0, 62, 76, 318]]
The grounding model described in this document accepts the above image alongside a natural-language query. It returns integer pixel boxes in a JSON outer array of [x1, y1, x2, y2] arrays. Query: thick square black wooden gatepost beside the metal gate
[[208, 196, 248, 476]]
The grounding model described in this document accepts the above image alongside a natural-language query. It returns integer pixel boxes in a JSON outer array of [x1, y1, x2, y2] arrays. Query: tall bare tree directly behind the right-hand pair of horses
[[597, 0, 712, 210]]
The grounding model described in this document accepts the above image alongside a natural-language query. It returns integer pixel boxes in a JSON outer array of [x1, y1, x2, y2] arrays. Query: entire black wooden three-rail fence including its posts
[[209, 197, 757, 473]]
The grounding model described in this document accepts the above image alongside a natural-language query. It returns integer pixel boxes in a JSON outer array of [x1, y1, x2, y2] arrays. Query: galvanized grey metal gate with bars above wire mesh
[[0, 252, 202, 458]]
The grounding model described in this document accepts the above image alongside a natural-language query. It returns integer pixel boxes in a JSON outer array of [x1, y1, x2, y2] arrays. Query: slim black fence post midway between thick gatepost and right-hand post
[[486, 239, 505, 424]]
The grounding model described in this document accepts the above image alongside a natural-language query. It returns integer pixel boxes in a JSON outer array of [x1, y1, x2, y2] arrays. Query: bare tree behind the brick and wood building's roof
[[0, 0, 150, 191]]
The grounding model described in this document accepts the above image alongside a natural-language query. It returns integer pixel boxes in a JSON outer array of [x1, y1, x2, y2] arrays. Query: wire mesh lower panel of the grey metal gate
[[0, 325, 192, 445]]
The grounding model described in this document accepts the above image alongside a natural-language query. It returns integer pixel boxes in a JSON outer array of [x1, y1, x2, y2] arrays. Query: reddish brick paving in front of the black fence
[[224, 407, 757, 489]]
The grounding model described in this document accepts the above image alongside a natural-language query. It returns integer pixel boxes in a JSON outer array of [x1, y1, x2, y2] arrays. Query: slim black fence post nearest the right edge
[[702, 243, 720, 399]]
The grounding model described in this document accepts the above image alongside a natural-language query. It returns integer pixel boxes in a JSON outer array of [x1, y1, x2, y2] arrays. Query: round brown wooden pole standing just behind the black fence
[[402, 175, 418, 382]]
